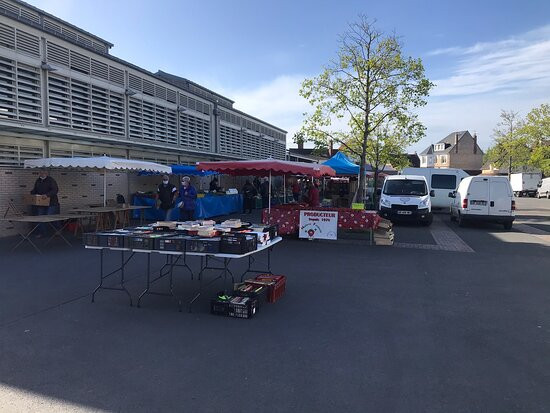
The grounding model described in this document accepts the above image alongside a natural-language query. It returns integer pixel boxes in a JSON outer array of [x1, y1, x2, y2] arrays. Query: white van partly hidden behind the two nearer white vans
[[401, 168, 470, 211]]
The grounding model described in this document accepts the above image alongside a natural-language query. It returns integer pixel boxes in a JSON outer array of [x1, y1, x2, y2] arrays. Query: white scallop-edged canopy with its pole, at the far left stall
[[24, 155, 172, 206]]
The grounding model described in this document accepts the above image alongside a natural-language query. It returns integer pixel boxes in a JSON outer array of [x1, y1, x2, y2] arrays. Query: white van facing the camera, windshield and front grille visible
[[378, 175, 433, 226]]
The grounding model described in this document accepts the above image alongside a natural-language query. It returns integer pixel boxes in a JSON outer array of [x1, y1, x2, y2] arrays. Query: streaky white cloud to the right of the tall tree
[[411, 25, 550, 151]]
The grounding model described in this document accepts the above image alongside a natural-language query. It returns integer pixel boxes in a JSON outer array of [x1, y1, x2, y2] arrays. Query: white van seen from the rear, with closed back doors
[[449, 175, 516, 229]]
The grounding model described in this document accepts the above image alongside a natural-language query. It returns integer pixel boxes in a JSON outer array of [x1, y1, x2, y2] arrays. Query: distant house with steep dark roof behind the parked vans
[[420, 131, 483, 174]]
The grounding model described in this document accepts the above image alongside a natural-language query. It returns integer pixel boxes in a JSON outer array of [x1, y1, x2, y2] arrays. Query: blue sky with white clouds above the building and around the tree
[[28, 0, 550, 151]]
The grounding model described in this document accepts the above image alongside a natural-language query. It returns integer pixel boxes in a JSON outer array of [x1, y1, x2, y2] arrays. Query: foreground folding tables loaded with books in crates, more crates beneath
[[84, 219, 285, 310]]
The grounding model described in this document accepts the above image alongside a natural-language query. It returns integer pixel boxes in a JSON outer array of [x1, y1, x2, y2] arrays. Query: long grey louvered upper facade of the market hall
[[0, 0, 286, 165]]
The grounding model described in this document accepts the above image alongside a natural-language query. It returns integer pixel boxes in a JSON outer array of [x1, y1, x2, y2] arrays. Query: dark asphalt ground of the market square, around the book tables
[[0, 198, 550, 412]]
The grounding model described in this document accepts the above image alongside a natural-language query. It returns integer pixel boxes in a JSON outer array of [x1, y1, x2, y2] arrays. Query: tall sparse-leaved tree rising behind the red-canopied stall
[[300, 15, 433, 201]]
